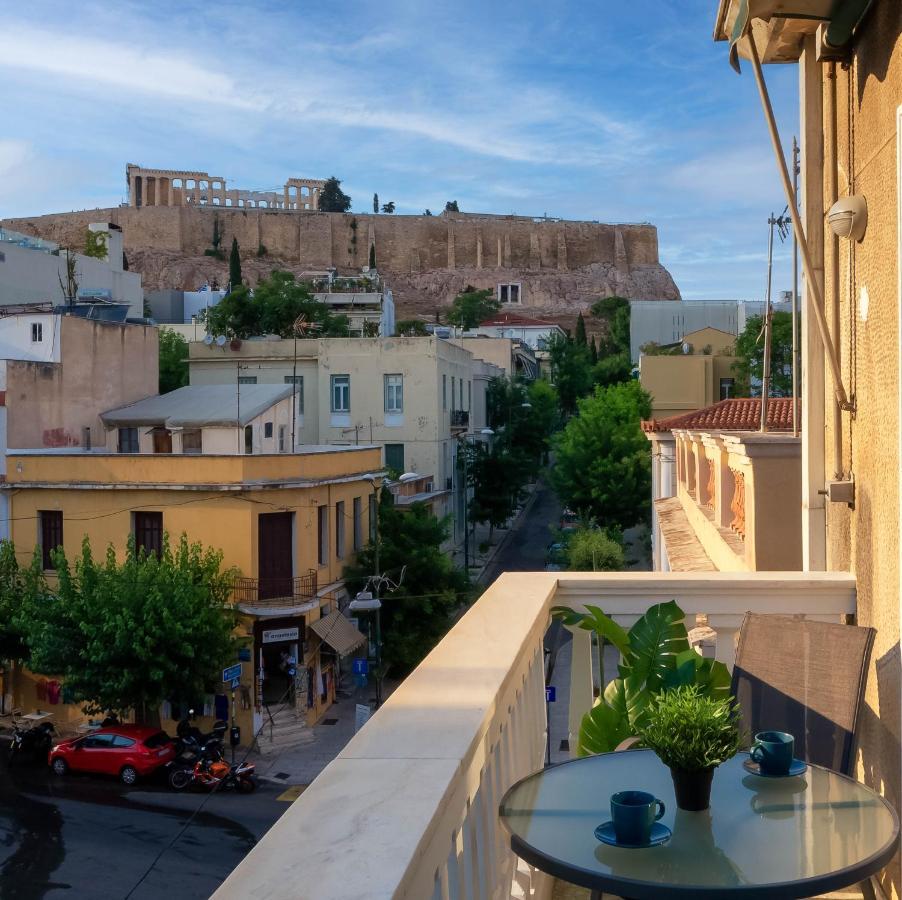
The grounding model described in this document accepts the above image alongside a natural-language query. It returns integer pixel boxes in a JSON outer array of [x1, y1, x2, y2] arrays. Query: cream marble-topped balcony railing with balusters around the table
[[215, 572, 855, 900]]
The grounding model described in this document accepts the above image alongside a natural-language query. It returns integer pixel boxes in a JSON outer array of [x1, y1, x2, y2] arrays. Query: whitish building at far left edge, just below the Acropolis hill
[[0, 222, 144, 319]]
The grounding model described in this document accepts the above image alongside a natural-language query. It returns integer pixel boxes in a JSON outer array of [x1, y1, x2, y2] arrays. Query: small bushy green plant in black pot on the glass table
[[641, 685, 741, 812]]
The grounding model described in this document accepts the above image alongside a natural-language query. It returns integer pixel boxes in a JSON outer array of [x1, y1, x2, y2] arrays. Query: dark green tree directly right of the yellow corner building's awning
[[345, 490, 469, 678]]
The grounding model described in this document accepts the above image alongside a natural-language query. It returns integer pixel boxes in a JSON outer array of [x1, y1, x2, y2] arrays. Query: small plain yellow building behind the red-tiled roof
[[639, 328, 736, 418]]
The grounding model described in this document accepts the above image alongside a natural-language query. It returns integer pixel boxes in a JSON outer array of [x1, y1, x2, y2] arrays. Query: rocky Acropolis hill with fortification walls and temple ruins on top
[[0, 167, 680, 320]]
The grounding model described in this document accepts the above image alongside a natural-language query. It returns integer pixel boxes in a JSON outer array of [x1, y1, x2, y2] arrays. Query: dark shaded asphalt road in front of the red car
[[0, 744, 289, 900]]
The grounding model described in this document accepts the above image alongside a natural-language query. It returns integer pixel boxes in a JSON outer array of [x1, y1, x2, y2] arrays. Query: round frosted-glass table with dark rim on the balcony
[[500, 750, 899, 900]]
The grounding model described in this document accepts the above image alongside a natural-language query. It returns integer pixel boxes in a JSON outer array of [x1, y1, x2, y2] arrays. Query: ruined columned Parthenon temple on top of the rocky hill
[[125, 163, 326, 210]]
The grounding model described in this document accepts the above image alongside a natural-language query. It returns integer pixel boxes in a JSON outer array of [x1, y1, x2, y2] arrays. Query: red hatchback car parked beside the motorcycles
[[49, 725, 175, 784]]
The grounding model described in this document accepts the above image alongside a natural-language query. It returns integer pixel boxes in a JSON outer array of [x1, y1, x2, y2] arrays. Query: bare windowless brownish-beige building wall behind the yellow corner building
[[6, 316, 159, 448]]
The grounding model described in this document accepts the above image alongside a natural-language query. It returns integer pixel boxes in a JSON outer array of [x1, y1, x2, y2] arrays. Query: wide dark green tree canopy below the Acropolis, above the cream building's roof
[[205, 269, 348, 338]]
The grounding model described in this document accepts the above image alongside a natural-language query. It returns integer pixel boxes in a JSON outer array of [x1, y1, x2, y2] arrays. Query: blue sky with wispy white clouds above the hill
[[0, 0, 798, 299]]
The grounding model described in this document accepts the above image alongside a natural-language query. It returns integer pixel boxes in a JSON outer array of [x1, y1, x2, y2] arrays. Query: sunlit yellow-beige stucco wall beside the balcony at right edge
[[824, 10, 902, 896]]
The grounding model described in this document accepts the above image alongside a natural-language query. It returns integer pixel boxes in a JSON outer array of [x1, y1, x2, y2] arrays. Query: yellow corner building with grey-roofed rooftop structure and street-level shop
[[4, 386, 380, 743]]
